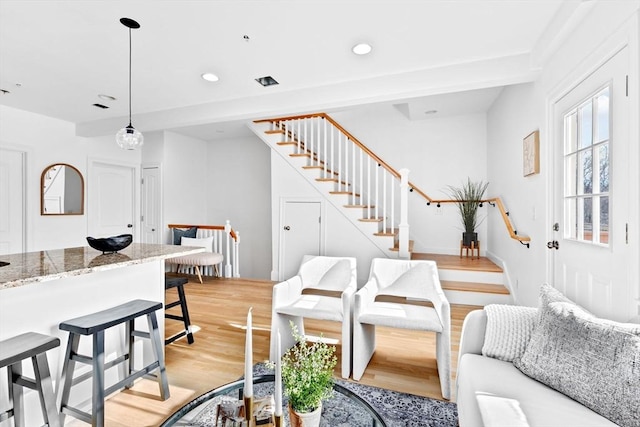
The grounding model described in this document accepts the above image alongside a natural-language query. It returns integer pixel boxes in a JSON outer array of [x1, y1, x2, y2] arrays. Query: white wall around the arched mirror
[[0, 105, 140, 251]]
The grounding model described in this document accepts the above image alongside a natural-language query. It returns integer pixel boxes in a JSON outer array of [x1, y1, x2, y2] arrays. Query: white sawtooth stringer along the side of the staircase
[[247, 122, 399, 258]]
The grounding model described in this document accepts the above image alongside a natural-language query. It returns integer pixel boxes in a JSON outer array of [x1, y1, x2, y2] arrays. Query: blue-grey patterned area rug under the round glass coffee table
[[188, 364, 458, 427]]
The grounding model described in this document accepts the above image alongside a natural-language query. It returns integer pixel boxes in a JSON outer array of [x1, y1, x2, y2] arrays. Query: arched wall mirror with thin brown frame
[[40, 163, 84, 215]]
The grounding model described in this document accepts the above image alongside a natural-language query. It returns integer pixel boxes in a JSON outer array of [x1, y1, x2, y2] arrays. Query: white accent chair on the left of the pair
[[270, 255, 358, 378]]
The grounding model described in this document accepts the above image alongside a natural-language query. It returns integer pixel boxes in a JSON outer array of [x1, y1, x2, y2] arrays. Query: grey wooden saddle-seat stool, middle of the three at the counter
[[57, 300, 169, 427]]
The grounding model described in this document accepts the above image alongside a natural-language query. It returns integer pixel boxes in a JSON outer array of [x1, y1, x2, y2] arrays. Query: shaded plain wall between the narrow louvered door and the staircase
[[206, 136, 271, 280]]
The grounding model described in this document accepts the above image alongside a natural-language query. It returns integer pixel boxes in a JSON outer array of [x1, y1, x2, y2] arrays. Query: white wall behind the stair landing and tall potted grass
[[330, 105, 488, 254]]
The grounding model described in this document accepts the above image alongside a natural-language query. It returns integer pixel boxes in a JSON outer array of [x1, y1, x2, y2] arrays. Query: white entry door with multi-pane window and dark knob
[[548, 48, 638, 321]]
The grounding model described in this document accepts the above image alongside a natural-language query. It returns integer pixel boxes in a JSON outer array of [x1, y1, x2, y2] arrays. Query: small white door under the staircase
[[279, 201, 322, 280]]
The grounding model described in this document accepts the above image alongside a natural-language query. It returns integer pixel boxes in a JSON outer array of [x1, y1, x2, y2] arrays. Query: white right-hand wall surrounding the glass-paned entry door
[[487, 1, 640, 310]]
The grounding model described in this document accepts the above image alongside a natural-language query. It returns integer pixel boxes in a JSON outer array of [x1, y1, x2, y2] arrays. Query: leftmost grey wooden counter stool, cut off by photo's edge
[[0, 332, 62, 427]]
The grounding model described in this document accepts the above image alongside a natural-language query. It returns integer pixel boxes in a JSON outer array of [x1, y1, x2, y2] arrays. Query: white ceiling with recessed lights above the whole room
[[0, 0, 581, 140]]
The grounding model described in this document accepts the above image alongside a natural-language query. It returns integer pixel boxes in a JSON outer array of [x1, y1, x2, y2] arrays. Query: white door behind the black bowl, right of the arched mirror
[[88, 162, 136, 239]]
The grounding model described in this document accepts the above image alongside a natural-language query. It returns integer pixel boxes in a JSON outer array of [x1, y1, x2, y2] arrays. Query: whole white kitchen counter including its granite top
[[0, 243, 204, 425]]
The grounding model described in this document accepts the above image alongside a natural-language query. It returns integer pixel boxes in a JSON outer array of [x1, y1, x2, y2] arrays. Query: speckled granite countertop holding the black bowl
[[0, 243, 204, 290]]
